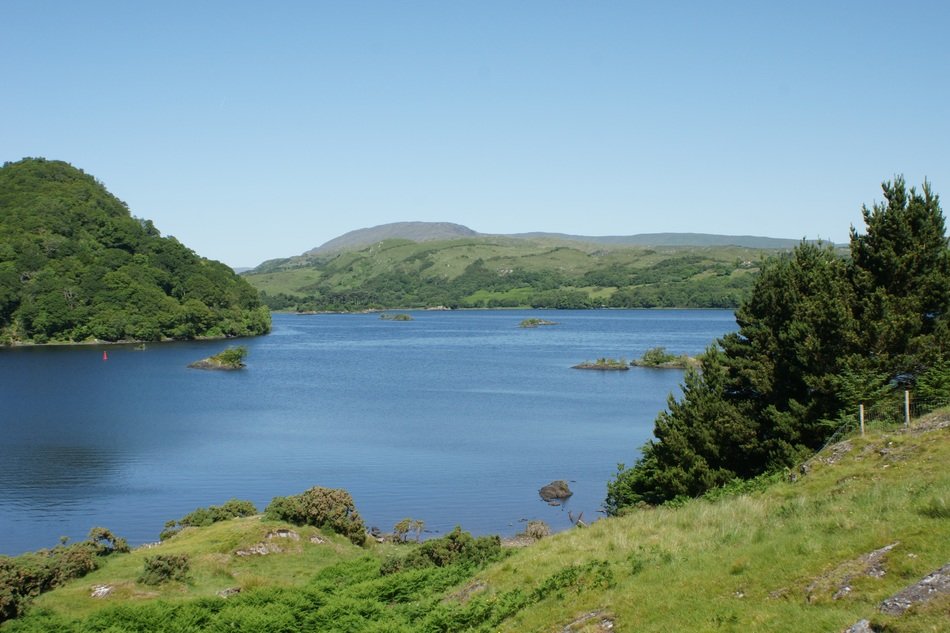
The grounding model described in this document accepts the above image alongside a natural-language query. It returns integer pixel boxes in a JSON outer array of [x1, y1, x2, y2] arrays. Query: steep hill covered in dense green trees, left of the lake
[[0, 158, 270, 344]]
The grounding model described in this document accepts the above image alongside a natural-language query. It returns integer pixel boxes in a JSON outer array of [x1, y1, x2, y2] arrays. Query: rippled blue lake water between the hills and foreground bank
[[0, 310, 735, 554]]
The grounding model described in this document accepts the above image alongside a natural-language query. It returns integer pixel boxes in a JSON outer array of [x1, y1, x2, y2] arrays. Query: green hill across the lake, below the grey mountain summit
[[245, 235, 776, 311]]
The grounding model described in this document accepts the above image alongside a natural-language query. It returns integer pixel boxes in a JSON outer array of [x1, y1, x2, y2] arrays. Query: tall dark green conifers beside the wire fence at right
[[606, 178, 950, 512]]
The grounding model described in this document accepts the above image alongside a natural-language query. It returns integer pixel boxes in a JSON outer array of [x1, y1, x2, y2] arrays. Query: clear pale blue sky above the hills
[[0, 0, 950, 266]]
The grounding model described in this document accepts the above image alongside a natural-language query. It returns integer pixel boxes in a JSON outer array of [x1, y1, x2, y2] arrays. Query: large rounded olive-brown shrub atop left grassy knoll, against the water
[[264, 486, 366, 545]]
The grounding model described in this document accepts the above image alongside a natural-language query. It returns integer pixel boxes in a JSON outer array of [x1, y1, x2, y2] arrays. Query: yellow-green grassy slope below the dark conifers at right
[[484, 418, 950, 631]]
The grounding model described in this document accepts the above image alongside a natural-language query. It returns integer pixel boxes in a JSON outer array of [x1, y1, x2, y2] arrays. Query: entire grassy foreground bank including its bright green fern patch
[[0, 410, 950, 633]]
